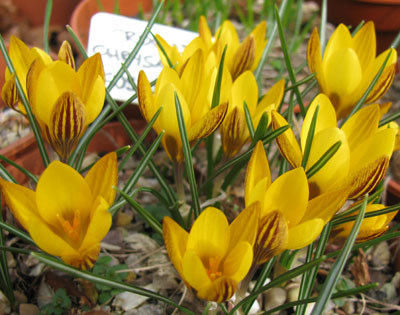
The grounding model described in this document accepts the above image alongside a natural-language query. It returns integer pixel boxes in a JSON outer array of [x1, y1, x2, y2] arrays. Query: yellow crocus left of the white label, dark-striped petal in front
[[27, 53, 105, 161]]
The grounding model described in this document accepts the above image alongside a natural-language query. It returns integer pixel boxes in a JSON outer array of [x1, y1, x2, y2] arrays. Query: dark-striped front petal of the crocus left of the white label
[[47, 92, 86, 161]]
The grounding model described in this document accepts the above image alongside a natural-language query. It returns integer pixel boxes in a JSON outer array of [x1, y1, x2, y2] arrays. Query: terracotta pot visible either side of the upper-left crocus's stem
[[0, 119, 147, 184]]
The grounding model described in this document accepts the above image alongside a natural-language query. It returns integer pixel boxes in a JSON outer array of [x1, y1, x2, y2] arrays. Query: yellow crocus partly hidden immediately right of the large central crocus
[[220, 71, 285, 158]]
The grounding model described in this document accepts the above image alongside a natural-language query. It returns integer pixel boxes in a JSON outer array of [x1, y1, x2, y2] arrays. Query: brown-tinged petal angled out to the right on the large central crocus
[[188, 103, 228, 141]]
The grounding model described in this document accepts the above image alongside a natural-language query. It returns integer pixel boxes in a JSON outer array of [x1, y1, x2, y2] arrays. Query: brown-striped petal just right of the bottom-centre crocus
[[254, 211, 288, 264]]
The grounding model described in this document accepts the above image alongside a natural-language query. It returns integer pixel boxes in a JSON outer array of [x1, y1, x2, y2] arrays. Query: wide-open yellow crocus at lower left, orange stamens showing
[[0, 152, 118, 269]]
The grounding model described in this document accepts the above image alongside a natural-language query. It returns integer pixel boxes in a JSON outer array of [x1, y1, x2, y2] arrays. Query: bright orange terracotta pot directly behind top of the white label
[[70, 0, 153, 46]]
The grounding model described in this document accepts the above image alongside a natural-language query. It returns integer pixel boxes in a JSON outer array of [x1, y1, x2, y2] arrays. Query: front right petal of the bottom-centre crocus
[[222, 241, 253, 283]]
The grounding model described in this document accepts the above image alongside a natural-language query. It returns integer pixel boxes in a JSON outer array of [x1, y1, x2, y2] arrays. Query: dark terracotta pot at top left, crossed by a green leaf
[[12, 0, 80, 27]]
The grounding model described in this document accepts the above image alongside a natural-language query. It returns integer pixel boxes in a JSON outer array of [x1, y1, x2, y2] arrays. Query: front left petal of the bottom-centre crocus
[[182, 250, 211, 291]]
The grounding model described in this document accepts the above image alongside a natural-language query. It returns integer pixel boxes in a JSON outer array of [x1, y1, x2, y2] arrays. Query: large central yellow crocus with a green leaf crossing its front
[[138, 50, 228, 163]]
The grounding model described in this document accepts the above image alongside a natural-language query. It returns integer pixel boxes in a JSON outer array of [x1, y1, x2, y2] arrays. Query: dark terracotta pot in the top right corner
[[315, 0, 400, 53]]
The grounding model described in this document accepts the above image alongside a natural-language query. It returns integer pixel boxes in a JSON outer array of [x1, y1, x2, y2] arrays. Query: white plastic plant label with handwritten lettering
[[88, 12, 197, 101]]
